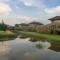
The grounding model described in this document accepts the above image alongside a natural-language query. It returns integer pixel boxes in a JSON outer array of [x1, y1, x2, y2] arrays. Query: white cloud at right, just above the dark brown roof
[[45, 6, 60, 16]]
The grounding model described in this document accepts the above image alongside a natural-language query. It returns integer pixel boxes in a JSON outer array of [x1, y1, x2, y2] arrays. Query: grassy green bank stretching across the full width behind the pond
[[0, 31, 60, 42]]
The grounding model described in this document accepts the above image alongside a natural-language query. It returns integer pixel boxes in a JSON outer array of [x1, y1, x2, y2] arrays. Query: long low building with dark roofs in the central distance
[[15, 22, 43, 31]]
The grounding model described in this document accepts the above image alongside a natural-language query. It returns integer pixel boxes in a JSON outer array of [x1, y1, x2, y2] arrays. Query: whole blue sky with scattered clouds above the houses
[[0, 0, 60, 25]]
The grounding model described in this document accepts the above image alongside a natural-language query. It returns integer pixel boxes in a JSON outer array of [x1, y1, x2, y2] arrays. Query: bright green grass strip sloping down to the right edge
[[19, 31, 60, 42]]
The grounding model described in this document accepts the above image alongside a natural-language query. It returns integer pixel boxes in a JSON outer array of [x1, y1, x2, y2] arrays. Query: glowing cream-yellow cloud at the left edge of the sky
[[0, 3, 12, 15]]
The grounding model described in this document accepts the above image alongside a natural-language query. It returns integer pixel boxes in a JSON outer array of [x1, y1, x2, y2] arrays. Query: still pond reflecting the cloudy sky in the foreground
[[0, 38, 60, 60]]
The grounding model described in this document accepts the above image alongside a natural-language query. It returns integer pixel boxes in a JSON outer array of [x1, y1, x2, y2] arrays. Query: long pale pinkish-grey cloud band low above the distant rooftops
[[0, 15, 42, 25]]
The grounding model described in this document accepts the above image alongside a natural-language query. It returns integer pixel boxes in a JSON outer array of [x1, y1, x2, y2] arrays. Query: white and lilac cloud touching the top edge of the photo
[[21, 0, 45, 8]]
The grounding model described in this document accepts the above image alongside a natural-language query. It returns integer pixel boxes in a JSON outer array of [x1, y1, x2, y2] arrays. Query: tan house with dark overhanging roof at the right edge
[[49, 16, 60, 33]]
